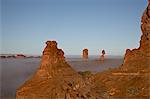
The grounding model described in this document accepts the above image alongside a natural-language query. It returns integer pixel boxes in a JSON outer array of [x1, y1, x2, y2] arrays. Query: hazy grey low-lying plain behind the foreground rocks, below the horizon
[[0, 57, 123, 99]]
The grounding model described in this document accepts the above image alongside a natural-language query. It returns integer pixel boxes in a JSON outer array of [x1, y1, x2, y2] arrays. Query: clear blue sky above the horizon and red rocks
[[0, 0, 147, 55]]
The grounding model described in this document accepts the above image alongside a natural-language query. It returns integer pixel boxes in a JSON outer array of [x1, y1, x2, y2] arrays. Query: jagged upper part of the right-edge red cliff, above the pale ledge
[[122, 3, 150, 71]]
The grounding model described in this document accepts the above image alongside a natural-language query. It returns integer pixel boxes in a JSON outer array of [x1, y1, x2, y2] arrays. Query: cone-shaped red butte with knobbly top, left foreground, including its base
[[16, 41, 101, 99]]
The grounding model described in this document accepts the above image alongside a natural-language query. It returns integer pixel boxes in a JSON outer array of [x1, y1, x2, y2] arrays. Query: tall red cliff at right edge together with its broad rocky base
[[92, 0, 150, 99]]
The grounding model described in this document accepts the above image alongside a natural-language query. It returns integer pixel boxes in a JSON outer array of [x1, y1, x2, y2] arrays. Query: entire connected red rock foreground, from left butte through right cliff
[[16, 3, 150, 99]]
